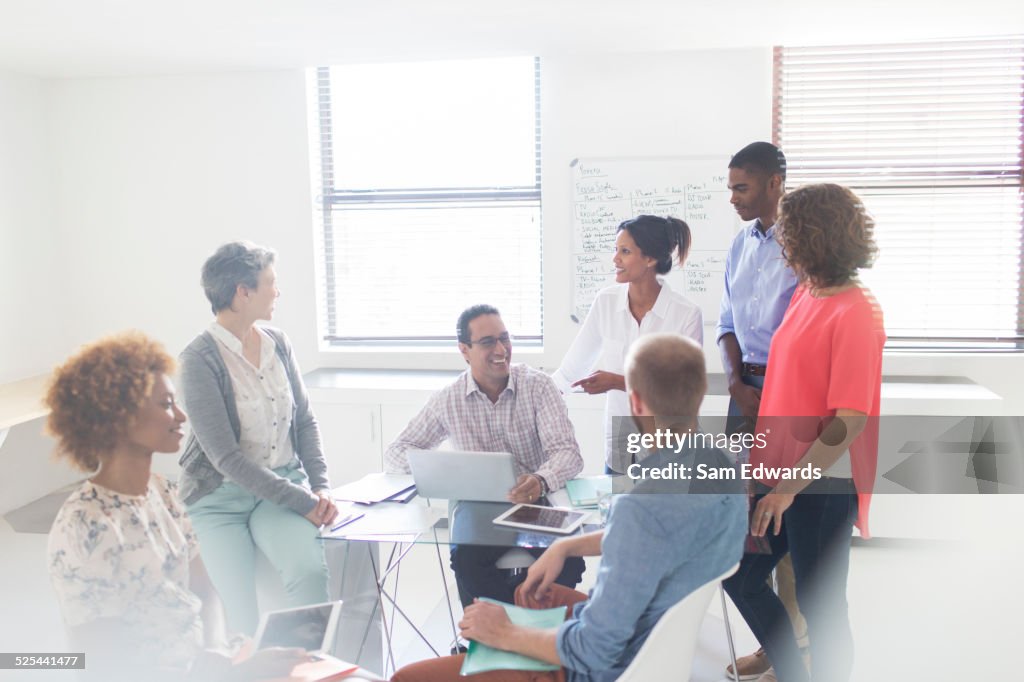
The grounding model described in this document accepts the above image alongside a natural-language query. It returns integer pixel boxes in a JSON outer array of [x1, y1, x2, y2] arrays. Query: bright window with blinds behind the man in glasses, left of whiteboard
[[313, 57, 544, 345]]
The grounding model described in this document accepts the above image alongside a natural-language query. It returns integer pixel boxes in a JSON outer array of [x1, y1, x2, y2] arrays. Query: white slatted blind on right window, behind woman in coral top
[[773, 37, 1024, 347]]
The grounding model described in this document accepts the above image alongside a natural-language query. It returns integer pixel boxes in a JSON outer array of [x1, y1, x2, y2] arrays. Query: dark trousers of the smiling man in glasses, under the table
[[452, 545, 587, 608]]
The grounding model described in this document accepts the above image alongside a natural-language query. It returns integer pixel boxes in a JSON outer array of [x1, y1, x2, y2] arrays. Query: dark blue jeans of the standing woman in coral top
[[725, 478, 857, 682]]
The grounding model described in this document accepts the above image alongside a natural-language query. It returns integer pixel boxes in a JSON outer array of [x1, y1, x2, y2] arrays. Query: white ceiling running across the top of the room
[[0, 0, 1024, 78]]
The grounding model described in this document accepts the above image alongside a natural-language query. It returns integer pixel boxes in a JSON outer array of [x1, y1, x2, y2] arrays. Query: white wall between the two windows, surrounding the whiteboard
[[541, 49, 772, 369]]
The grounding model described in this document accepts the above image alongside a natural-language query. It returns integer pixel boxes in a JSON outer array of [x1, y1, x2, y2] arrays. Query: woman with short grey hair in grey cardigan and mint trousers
[[180, 242, 338, 634]]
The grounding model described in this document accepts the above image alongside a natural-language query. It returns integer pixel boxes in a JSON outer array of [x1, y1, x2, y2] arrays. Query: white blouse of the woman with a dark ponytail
[[552, 280, 703, 473]]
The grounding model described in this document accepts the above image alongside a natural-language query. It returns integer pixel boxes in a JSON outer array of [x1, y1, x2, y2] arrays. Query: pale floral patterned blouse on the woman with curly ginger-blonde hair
[[48, 474, 203, 669]]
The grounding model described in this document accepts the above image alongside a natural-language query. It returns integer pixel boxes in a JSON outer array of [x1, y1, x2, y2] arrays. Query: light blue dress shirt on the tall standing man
[[716, 220, 797, 365]]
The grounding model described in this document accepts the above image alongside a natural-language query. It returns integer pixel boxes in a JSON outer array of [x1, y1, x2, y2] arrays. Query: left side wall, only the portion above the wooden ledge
[[0, 73, 63, 384]]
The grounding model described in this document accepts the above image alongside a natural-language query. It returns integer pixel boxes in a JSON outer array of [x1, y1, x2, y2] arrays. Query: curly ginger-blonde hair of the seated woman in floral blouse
[[44, 332, 174, 471]]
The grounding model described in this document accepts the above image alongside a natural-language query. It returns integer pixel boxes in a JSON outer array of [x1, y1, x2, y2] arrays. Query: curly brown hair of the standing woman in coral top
[[778, 184, 878, 288]]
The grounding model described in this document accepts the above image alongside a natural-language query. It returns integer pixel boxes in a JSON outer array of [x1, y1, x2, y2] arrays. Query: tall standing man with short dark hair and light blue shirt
[[718, 142, 807, 682]]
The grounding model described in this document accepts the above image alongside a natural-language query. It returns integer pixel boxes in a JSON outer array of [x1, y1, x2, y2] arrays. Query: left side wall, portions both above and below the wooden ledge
[[0, 73, 78, 513]]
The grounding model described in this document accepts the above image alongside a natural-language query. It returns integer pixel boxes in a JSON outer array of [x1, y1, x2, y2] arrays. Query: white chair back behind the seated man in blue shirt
[[617, 563, 739, 682]]
